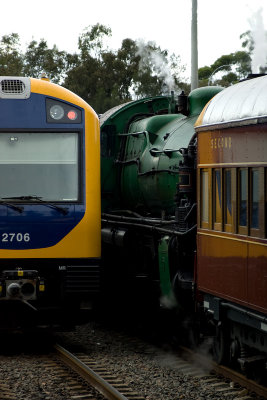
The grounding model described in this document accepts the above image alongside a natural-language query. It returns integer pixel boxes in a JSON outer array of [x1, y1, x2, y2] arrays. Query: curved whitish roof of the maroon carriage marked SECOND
[[196, 76, 267, 129]]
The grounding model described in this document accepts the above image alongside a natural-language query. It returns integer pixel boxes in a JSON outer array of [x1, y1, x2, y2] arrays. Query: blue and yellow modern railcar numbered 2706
[[0, 77, 101, 328]]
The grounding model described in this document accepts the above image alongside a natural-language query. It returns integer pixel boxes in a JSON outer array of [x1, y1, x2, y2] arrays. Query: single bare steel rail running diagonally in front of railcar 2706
[[54, 344, 128, 400]]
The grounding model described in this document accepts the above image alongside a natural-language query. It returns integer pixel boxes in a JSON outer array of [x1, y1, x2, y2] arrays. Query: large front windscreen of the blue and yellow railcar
[[0, 132, 79, 202]]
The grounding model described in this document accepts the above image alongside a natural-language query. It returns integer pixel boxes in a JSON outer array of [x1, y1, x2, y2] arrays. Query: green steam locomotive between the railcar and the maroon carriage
[[100, 87, 221, 313]]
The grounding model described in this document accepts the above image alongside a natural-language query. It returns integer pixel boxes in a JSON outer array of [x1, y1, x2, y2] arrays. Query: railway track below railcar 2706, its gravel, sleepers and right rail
[[0, 344, 145, 400]]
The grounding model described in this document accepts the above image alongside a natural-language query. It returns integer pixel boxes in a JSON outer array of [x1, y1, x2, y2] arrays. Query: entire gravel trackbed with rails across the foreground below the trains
[[0, 327, 267, 400]]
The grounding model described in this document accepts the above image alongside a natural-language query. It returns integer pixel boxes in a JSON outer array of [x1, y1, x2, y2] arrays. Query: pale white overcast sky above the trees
[[0, 0, 267, 76]]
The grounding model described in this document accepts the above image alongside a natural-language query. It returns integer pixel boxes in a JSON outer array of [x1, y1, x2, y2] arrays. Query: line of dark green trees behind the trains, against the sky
[[0, 24, 262, 113]]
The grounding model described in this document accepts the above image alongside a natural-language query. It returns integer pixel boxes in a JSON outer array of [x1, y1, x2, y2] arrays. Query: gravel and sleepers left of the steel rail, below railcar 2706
[[0, 352, 103, 400]]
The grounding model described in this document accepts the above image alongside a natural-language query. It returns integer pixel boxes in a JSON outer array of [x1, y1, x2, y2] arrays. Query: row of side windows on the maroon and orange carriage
[[200, 167, 267, 237]]
